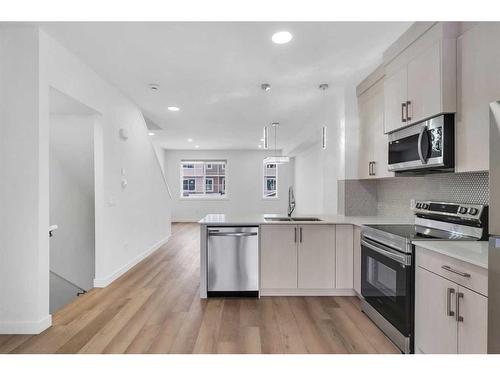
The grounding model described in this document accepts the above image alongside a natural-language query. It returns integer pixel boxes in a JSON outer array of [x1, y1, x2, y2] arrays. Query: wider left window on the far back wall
[[180, 160, 226, 198]]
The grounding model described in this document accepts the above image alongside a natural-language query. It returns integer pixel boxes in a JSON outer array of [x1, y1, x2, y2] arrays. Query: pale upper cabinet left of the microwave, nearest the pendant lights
[[357, 67, 394, 179]]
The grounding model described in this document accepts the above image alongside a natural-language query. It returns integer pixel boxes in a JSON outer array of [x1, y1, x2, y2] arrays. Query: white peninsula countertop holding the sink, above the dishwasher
[[198, 214, 413, 226]]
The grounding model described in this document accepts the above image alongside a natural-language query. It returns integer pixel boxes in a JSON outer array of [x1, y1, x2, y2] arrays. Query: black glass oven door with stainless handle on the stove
[[361, 237, 414, 336]]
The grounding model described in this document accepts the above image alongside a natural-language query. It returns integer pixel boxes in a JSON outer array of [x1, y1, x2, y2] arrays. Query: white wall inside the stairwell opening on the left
[[50, 116, 95, 290]]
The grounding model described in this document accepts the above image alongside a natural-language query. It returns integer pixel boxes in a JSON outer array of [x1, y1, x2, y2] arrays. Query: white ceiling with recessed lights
[[43, 22, 410, 149]]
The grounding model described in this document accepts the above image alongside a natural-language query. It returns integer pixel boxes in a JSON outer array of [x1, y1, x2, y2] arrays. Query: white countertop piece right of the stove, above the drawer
[[413, 241, 488, 269]]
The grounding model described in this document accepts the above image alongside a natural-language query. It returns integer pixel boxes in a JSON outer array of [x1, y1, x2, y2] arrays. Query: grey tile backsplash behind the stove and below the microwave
[[339, 172, 489, 217]]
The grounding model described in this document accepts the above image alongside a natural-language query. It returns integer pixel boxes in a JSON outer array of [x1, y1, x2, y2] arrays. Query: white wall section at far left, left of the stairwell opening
[[0, 26, 51, 333]]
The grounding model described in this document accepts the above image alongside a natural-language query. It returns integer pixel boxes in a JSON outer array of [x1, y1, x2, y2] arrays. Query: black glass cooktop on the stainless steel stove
[[365, 224, 477, 241]]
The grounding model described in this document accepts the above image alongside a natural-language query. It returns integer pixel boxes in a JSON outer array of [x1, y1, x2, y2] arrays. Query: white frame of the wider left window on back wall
[[179, 159, 229, 200]]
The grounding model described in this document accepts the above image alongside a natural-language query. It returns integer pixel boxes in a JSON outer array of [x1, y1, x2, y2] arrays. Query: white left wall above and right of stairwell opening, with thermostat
[[40, 31, 170, 286]]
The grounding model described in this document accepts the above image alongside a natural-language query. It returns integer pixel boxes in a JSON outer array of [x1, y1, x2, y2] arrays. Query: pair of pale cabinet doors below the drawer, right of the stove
[[415, 267, 488, 354]]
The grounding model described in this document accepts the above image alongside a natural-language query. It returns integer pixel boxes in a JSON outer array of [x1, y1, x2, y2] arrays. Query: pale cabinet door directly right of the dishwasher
[[260, 224, 298, 289]]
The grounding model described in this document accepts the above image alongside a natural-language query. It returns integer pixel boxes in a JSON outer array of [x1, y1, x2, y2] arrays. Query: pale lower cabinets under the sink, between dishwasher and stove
[[260, 224, 353, 295]]
